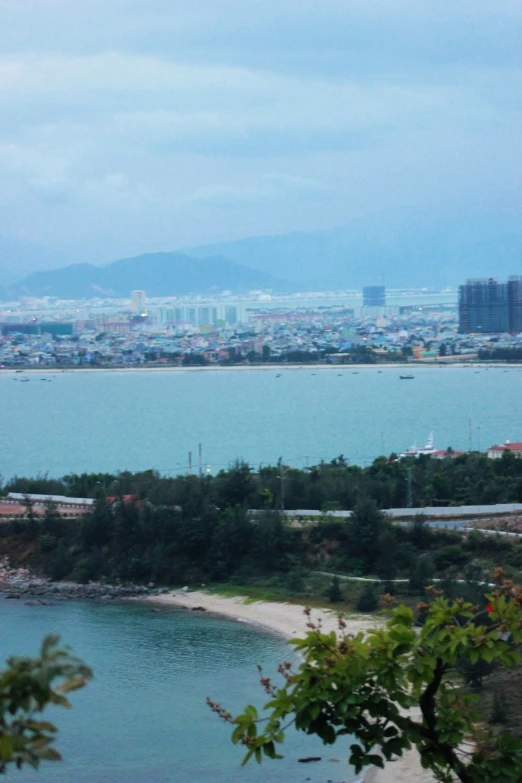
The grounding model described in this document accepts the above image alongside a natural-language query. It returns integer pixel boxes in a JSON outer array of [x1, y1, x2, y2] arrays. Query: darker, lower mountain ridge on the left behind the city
[[0, 253, 288, 299]]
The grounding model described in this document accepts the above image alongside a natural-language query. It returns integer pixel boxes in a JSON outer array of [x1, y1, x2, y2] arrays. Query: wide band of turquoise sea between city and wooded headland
[[0, 367, 522, 477]]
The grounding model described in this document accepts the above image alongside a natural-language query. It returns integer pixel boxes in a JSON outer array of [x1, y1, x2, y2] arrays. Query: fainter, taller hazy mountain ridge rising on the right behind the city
[[183, 209, 522, 291]]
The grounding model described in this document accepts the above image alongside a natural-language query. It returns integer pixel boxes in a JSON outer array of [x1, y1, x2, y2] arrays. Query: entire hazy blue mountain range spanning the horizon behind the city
[[0, 210, 522, 299]]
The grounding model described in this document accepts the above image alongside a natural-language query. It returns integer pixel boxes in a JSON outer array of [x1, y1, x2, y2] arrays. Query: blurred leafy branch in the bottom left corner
[[0, 636, 92, 774]]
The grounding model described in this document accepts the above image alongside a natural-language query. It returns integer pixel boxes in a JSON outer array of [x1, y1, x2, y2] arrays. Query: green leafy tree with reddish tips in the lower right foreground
[[209, 570, 522, 783]]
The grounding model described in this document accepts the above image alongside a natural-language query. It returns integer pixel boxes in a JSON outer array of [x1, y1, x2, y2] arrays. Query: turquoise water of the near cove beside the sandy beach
[[0, 598, 355, 783]]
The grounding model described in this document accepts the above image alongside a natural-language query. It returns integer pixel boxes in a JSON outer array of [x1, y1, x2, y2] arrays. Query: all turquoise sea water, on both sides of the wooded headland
[[0, 368, 512, 783]]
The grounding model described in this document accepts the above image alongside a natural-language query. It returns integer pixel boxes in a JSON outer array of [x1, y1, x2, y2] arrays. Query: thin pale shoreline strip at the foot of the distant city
[[0, 361, 522, 375]]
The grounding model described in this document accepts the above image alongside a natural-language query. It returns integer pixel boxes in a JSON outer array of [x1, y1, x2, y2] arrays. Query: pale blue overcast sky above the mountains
[[0, 0, 522, 262]]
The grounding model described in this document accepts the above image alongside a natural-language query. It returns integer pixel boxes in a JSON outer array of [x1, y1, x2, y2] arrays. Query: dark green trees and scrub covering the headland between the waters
[[1, 454, 522, 595]]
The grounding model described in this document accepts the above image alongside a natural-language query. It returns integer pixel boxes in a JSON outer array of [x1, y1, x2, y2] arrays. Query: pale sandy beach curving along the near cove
[[139, 590, 435, 783]]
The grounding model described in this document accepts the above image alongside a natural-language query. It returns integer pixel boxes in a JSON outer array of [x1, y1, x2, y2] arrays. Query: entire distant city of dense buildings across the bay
[[0, 278, 522, 368]]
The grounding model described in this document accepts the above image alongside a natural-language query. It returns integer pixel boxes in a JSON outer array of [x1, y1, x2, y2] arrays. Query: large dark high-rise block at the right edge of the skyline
[[459, 277, 522, 334]]
